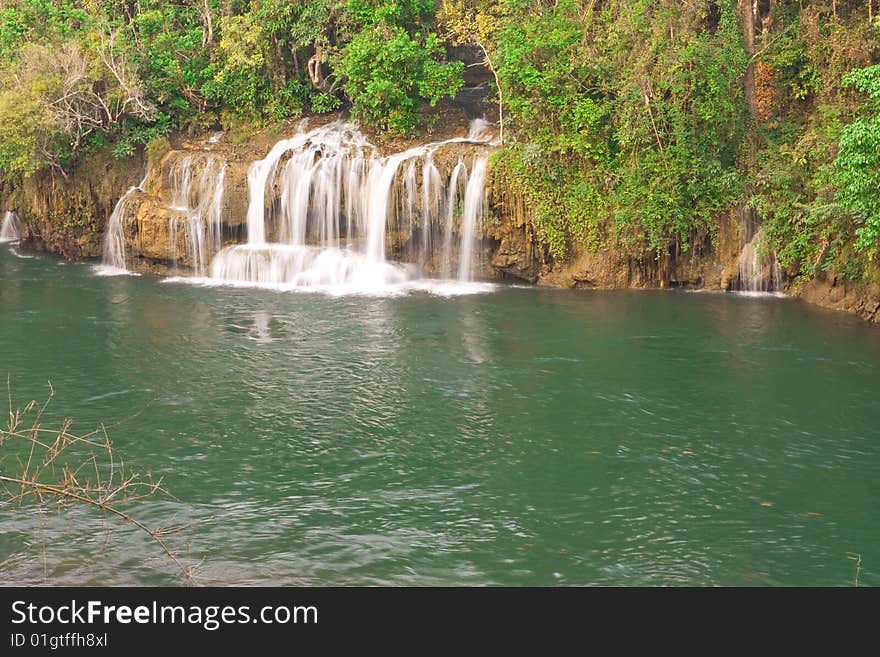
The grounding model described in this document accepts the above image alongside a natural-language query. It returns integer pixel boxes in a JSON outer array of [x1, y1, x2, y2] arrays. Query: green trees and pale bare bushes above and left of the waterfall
[[0, 0, 462, 175]]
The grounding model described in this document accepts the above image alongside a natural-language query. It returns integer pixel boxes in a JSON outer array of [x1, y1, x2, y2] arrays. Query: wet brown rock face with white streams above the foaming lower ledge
[[114, 114, 495, 278]]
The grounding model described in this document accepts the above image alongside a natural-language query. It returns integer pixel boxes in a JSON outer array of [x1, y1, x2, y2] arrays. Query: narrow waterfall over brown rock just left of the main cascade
[[168, 154, 226, 276]]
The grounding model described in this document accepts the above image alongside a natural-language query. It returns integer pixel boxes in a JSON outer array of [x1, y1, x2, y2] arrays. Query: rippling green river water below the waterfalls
[[0, 245, 880, 586]]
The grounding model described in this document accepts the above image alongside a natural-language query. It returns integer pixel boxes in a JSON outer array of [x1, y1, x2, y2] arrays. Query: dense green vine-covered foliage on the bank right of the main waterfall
[[478, 0, 880, 280]]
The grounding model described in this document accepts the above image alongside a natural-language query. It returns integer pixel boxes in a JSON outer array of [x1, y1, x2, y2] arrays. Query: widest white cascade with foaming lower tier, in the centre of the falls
[[211, 122, 491, 290]]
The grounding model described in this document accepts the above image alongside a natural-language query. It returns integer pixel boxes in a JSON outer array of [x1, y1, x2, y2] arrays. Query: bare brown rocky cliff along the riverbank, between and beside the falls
[[0, 110, 880, 322]]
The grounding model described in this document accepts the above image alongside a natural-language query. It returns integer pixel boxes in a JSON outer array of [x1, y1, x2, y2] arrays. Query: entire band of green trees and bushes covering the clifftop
[[0, 0, 880, 280]]
